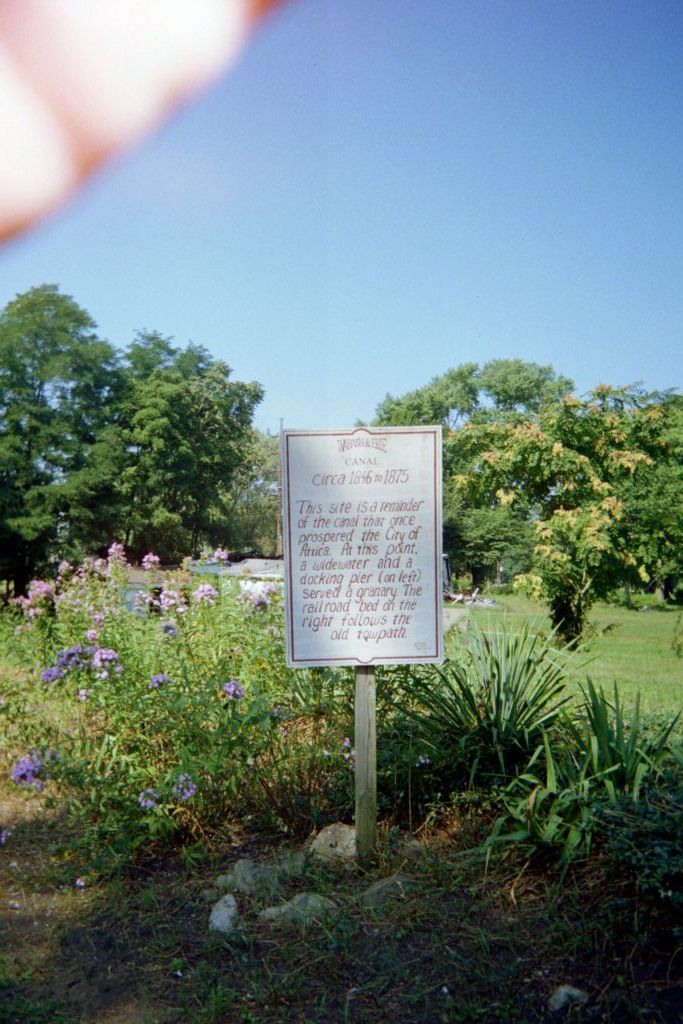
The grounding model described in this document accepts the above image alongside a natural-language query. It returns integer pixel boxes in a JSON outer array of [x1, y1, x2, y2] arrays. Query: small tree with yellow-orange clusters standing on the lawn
[[454, 386, 664, 640]]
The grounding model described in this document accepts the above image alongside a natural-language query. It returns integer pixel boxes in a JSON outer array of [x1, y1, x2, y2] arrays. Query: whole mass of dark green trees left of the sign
[[0, 285, 262, 594]]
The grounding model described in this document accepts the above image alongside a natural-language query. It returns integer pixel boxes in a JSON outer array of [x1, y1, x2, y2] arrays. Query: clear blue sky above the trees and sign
[[0, 0, 683, 431]]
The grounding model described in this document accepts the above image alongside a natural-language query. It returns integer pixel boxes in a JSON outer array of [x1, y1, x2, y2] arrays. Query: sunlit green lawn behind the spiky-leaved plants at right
[[471, 595, 683, 714]]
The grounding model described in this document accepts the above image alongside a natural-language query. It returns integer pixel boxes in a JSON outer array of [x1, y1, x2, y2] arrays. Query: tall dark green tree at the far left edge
[[0, 285, 122, 594]]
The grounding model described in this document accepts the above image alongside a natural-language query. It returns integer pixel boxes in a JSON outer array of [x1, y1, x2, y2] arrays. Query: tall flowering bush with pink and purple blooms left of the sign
[[5, 544, 352, 853]]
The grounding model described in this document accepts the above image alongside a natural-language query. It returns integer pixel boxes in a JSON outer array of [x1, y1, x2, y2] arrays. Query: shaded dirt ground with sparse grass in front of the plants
[[0, 794, 683, 1024]]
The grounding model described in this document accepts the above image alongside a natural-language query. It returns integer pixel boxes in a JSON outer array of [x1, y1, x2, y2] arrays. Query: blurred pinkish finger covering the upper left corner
[[0, 0, 280, 238]]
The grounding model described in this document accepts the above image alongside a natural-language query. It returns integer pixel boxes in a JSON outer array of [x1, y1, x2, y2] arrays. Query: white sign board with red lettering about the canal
[[282, 427, 443, 667]]
